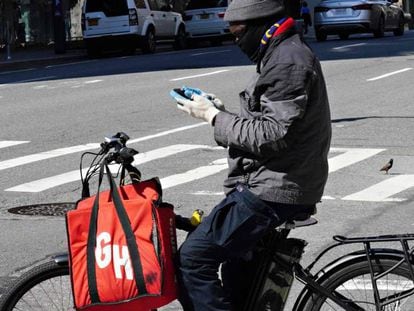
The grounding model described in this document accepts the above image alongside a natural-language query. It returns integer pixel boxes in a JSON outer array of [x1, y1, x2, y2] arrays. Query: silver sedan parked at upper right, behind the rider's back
[[314, 0, 405, 41]]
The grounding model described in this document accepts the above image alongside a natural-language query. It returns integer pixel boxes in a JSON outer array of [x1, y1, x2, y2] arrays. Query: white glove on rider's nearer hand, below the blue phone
[[177, 94, 224, 125]]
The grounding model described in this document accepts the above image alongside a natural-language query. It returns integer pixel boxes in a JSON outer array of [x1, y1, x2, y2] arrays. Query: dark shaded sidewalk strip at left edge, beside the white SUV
[[0, 46, 86, 72]]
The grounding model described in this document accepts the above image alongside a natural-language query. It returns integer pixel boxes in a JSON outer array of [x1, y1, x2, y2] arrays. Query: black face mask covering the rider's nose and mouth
[[237, 24, 268, 63]]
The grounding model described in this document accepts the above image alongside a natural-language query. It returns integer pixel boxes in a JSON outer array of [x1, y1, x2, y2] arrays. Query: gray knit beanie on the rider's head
[[224, 0, 285, 22]]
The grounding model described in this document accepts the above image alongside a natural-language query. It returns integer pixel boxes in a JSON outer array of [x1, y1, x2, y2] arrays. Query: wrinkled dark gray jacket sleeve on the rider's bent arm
[[214, 64, 311, 156]]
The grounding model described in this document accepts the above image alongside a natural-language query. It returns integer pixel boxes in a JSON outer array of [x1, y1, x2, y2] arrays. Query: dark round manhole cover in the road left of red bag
[[8, 203, 75, 216]]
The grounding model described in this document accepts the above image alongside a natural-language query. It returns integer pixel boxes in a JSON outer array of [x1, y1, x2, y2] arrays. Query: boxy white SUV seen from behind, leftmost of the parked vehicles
[[82, 0, 186, 56]]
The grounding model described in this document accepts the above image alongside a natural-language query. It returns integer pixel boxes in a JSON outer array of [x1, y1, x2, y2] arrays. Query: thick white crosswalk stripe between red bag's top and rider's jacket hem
[[161, 158, 228, 189]]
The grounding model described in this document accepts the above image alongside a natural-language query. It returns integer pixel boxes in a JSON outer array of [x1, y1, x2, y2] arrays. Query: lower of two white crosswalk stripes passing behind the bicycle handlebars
[[5, 144, 223, 192]]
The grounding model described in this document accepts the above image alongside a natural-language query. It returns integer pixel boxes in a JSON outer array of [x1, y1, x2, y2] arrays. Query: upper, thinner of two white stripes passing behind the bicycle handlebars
[[0, 122, 208, 171]]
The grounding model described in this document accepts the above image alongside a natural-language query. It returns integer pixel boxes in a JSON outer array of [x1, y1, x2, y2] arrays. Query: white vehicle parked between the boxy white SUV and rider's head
[[183, 0, 231, 45]]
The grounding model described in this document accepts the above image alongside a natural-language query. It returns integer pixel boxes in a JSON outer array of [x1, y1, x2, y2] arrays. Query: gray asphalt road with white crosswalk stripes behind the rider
[[0, 31, 414, 310]]
